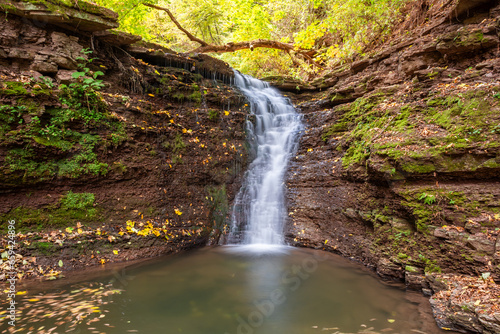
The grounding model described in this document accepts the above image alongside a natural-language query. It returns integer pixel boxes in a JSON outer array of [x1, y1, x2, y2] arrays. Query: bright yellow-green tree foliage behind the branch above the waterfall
[[95, 0, 410, 78]]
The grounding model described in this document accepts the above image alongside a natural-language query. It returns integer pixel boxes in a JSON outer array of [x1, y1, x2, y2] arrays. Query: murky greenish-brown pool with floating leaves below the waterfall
[[0, 246, 458, 334]]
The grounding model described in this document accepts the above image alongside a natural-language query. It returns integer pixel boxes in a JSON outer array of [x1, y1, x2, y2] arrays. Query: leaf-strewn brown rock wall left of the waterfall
[[0, 0, 247, 280]]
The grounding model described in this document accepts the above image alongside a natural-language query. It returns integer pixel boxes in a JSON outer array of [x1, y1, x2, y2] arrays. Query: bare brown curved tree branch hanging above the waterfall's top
[[143, 3, 319, 66]]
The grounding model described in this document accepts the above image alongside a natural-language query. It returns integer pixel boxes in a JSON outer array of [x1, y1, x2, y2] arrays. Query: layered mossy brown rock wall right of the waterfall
[[282, 1, 500, 333]]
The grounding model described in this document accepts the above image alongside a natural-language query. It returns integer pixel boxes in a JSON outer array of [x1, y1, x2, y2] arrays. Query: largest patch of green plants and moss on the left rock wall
[[0, 49, 120, 182]]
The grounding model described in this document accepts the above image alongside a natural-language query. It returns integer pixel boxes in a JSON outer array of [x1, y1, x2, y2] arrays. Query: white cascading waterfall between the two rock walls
[[228, 72, 303, 247]]
